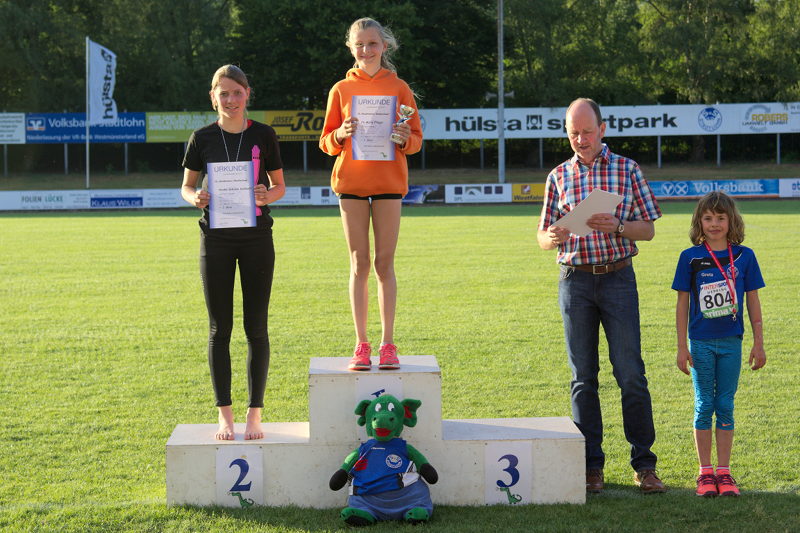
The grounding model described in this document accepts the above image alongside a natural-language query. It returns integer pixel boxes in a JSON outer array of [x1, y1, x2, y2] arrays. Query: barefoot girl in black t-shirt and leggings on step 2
[[181, 65, 286, 440]]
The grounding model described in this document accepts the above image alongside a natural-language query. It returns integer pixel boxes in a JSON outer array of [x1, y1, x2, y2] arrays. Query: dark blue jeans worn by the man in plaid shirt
[[558, 265, 656, 470]]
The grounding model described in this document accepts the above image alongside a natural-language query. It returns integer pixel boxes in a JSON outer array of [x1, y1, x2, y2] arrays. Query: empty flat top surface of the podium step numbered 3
[[442, 416, 583, 441]]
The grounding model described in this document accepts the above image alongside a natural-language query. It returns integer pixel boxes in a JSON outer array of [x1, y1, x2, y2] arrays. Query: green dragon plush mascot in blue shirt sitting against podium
[[329, 394, 439, 526]]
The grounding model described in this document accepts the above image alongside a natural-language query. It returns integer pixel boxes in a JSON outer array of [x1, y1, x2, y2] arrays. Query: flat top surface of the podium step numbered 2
[[167, 422, 308, 446]]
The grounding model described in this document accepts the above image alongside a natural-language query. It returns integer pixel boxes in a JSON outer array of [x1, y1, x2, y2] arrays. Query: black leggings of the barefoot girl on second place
[[200, 228, 275, 407]]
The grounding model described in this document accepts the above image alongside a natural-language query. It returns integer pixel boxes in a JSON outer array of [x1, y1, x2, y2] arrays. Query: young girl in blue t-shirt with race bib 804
[[672, 191, 767, 496]]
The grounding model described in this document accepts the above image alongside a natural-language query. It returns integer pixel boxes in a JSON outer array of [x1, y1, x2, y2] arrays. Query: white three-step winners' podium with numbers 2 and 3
[[166, 356, 586, 508]]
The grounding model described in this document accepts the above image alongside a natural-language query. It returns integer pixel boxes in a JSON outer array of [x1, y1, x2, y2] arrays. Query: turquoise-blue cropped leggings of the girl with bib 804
[[689, 335, 742, 430]]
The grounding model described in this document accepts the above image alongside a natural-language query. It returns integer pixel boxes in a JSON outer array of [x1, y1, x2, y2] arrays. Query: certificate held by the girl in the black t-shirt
[[206, 161, 256, 228]]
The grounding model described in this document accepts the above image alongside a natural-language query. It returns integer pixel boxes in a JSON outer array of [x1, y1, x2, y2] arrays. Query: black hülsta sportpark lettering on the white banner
[[444, 113, 678, 133]]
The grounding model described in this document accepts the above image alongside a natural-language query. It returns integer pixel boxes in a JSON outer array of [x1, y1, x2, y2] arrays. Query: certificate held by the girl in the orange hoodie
[[350, 95, 397, 161]]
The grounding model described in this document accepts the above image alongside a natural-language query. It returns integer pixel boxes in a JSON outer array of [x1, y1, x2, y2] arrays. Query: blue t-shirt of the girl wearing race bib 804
[[672, 244, 764, 340]]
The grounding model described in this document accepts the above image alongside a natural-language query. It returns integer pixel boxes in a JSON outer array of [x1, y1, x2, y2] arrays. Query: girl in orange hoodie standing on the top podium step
[[319, 18, 422, 370]]
